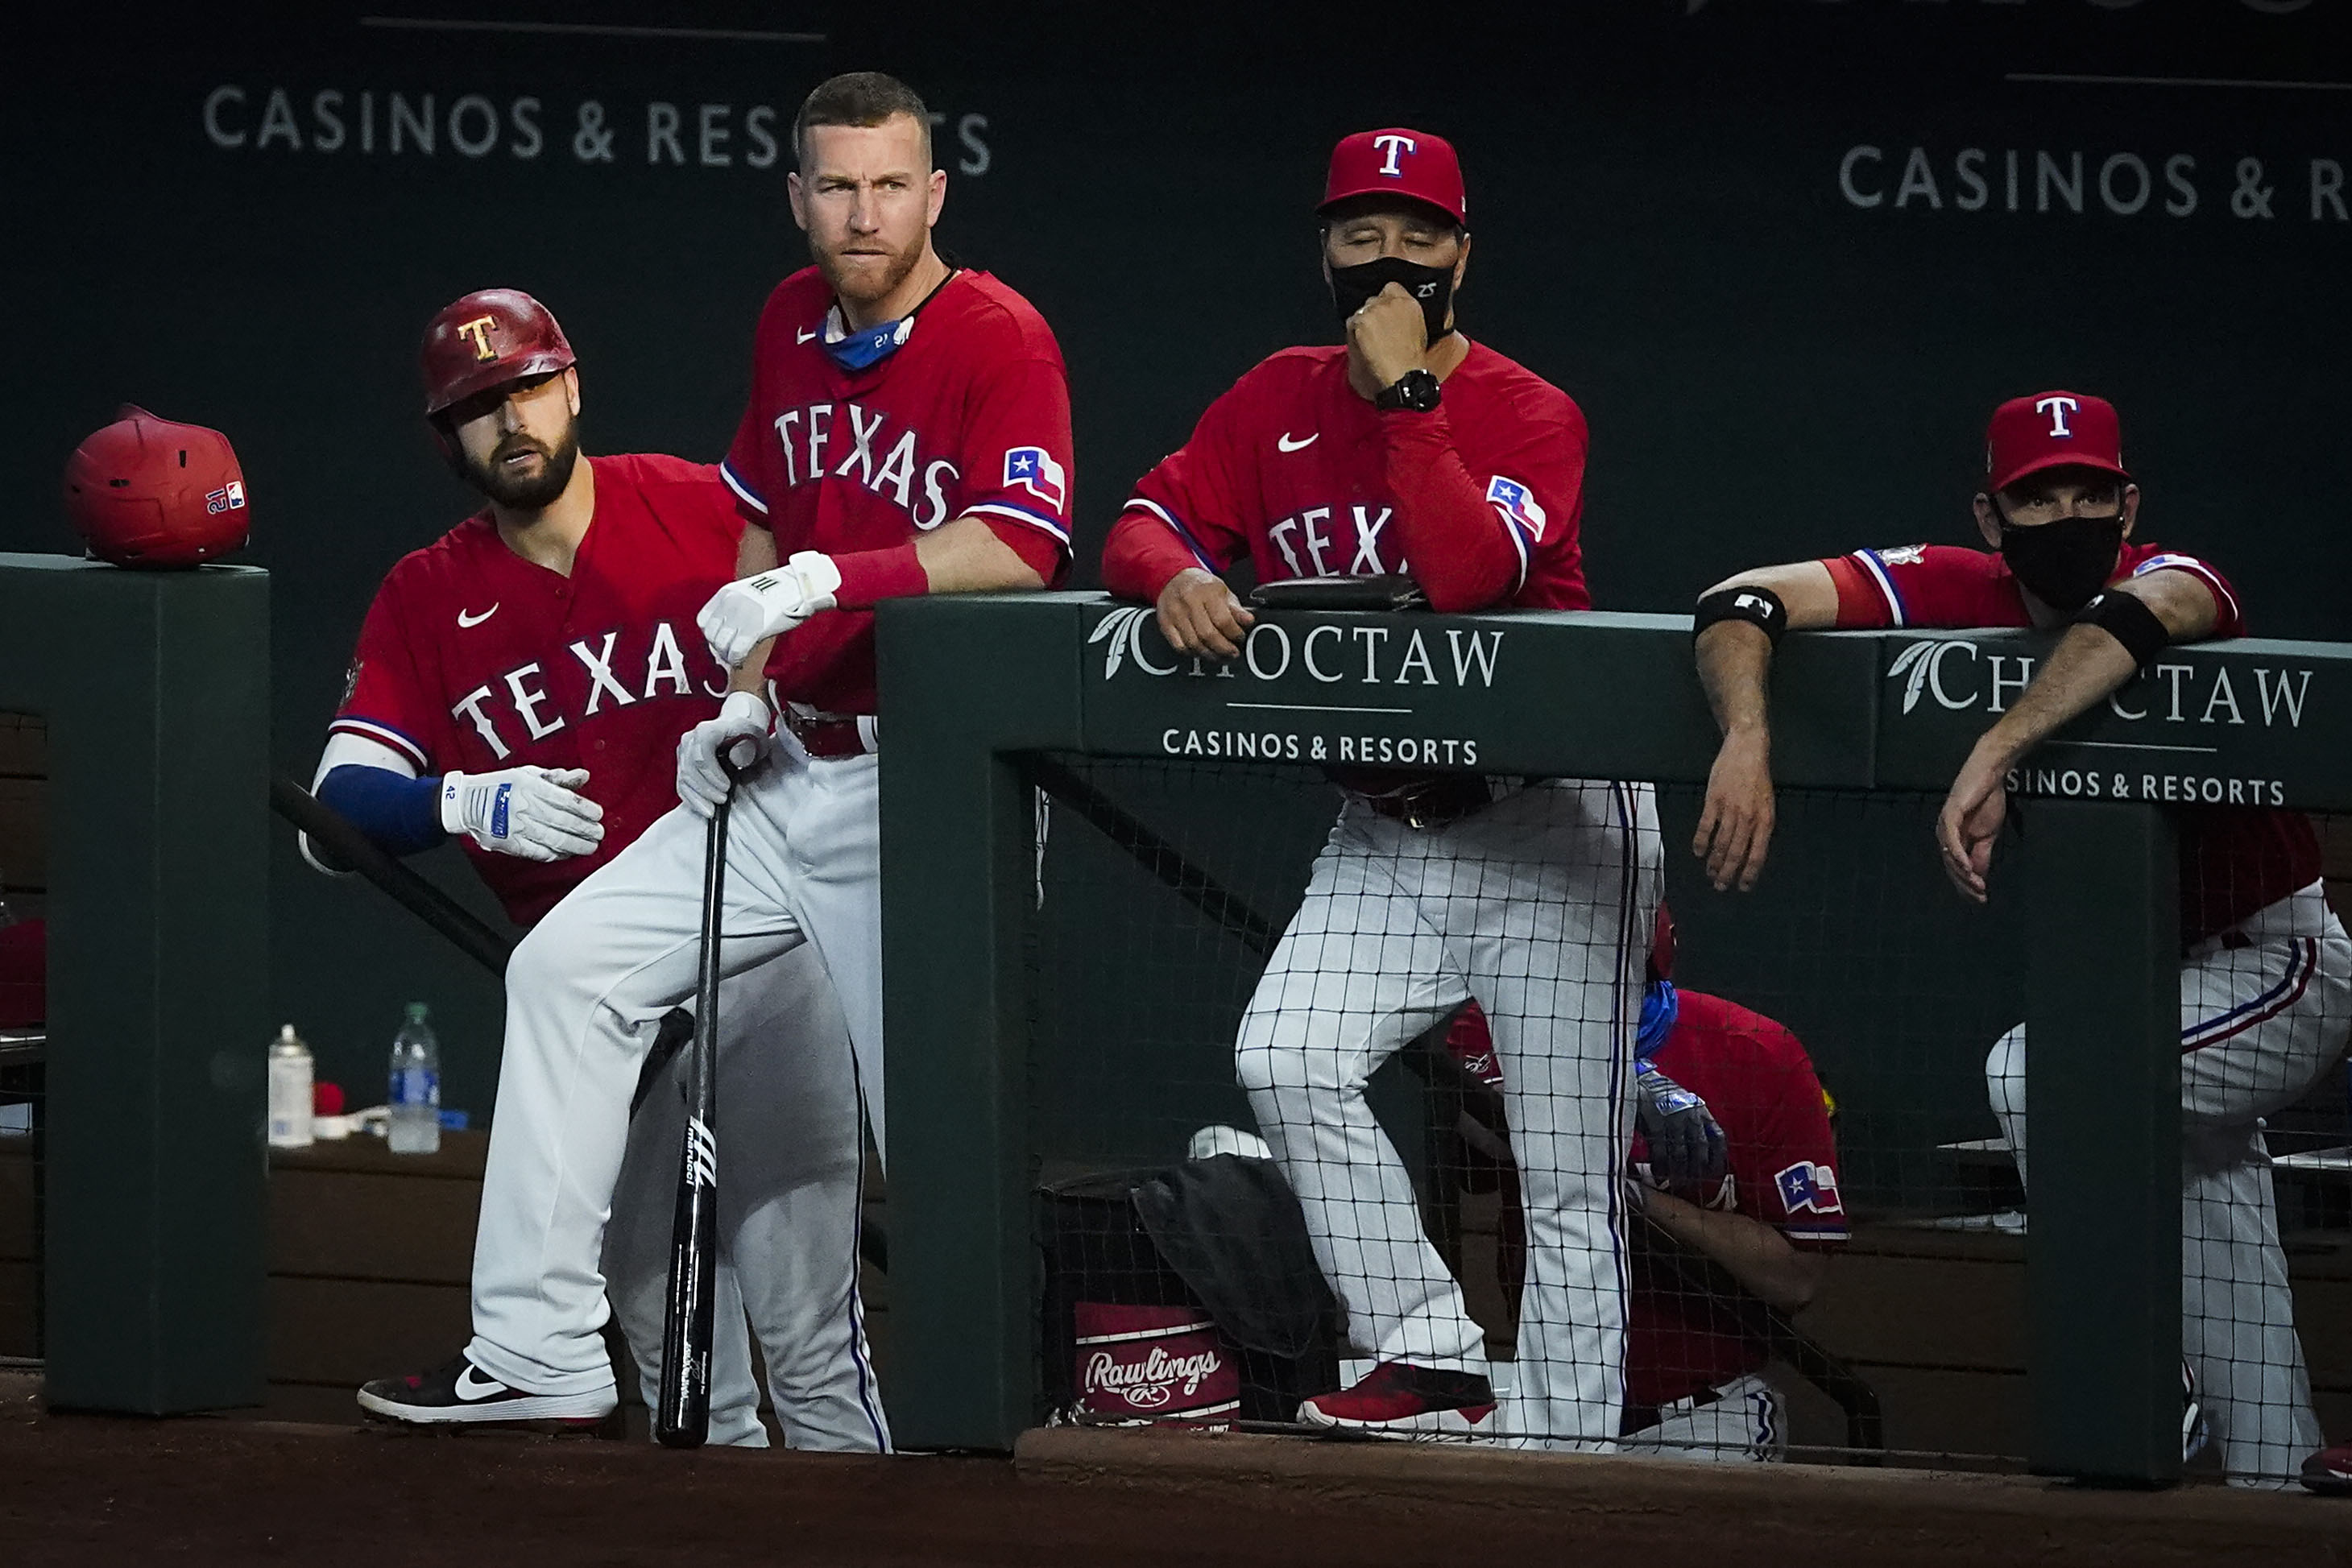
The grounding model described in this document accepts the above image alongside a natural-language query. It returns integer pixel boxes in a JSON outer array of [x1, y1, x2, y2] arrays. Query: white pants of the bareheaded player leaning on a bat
[[468, 734, 889, 1453]]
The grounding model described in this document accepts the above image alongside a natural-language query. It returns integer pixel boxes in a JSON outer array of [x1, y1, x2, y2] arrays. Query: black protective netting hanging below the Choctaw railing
[[1030, 755, 2352, 1481]]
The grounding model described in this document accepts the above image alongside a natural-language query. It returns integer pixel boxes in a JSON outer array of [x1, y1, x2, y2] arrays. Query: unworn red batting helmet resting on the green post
[[66, 404, 251, 566]]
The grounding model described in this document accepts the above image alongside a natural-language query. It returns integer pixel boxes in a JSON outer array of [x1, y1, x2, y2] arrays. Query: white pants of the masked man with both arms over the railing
[[1985, 882, 2352, 1486]]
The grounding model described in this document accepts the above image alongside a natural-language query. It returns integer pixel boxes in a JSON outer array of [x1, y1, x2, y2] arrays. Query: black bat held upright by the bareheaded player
[[654, 752, 741, 1448]]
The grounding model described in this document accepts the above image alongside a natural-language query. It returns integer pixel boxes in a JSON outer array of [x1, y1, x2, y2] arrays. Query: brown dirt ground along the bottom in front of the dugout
[[0, 1384, 2352, 1568]]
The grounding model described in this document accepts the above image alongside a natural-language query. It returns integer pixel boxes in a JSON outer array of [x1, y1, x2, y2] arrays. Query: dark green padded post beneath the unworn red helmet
[[0, 555, 273, 1415]]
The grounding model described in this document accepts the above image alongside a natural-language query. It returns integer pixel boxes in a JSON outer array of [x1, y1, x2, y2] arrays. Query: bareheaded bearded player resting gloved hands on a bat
[[359, 72, 1075, 1450]]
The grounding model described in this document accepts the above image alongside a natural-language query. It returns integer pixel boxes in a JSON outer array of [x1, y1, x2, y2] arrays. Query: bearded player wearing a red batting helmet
[[326, 289, 854, 1446]]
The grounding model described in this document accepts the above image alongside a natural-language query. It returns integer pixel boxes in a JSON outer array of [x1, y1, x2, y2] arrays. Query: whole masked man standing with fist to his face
[[1103, 127, 1658, 1443]]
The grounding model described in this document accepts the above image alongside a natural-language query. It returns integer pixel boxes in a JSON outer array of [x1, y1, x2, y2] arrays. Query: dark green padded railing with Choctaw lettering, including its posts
[[880, 595, 2352, 1486]]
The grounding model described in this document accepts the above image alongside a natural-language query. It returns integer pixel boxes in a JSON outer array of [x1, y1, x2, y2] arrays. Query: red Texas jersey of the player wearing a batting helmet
[[329, 456, 743, 926]]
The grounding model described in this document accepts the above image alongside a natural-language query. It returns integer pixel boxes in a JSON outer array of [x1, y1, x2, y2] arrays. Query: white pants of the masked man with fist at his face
[[1235, 780, 1663, 1448]]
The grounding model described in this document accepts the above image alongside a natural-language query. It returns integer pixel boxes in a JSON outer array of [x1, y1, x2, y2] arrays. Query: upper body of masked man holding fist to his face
[[1103, 130, 1592, 635]]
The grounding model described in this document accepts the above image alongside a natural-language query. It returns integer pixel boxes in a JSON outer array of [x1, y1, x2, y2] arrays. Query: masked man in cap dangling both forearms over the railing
[[1693, 391, 2352, 1486]]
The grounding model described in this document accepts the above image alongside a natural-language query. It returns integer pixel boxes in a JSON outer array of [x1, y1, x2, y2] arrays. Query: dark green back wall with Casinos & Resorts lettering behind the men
[[0, 0, 2352, 1107]]
